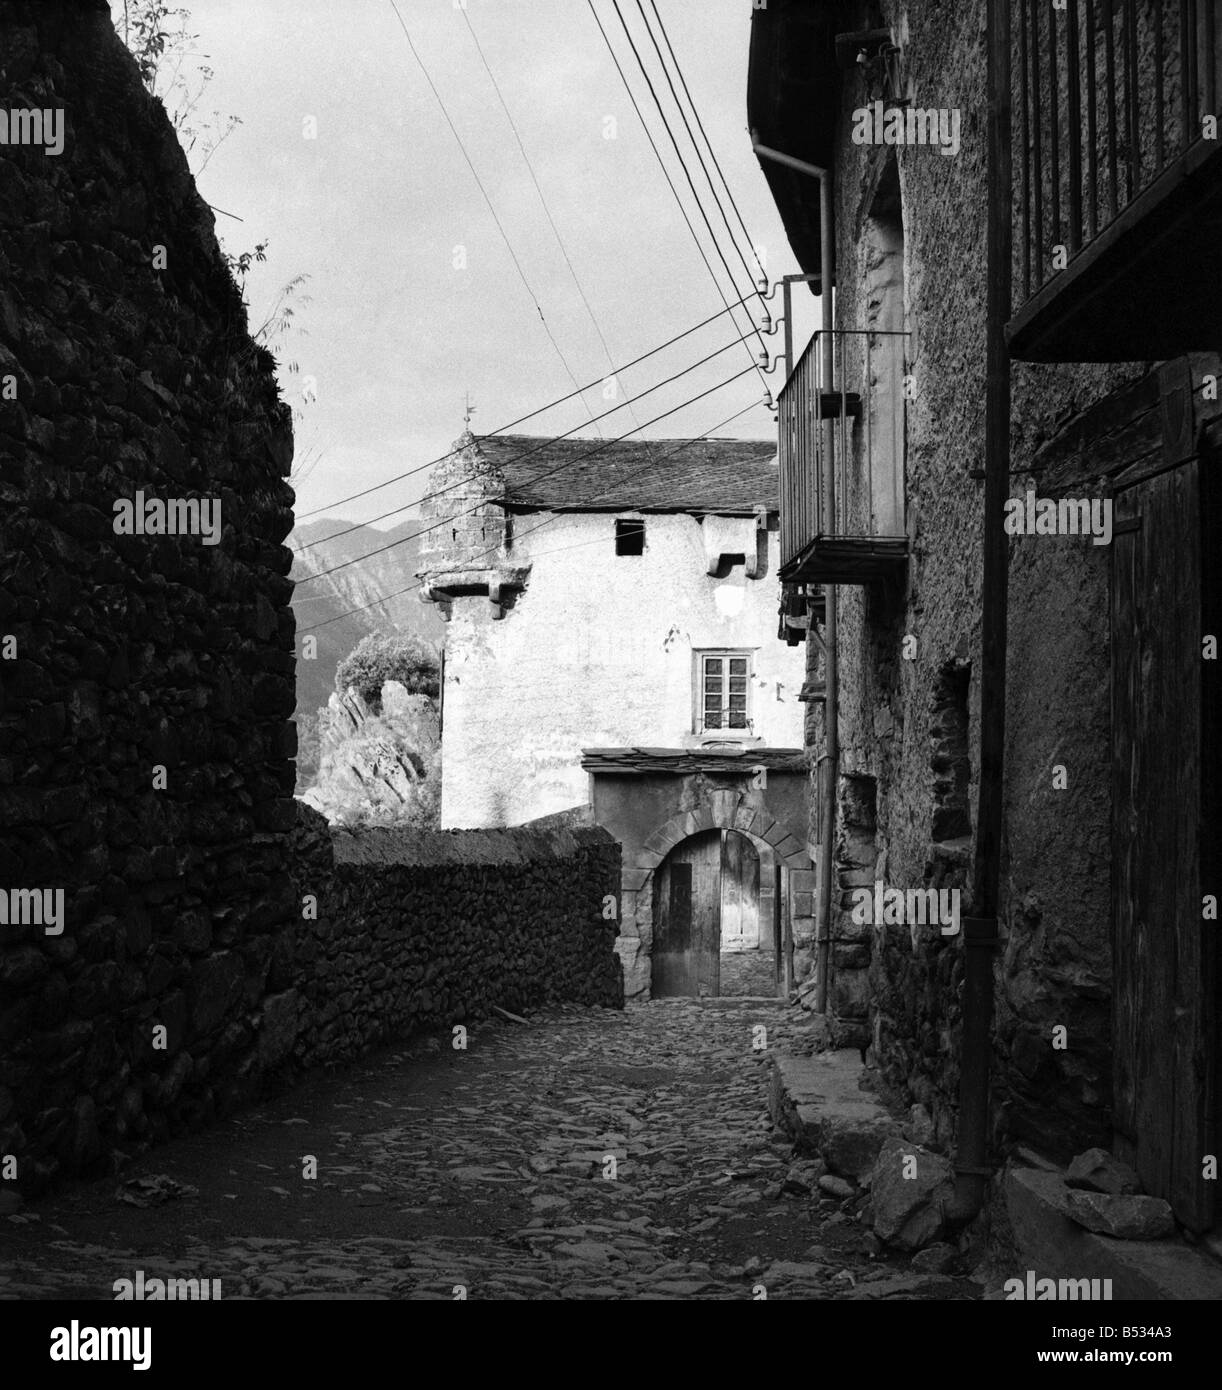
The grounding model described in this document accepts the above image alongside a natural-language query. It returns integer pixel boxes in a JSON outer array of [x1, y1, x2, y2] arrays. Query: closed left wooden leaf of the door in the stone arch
[[651, 830, 722, 998]]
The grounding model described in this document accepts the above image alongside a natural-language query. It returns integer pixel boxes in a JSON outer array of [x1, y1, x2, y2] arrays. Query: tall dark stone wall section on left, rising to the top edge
[[0, 0, 295, 1188]]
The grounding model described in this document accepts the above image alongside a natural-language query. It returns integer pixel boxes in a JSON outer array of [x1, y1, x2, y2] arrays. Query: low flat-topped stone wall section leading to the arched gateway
[[291, 806, 624, 1066]]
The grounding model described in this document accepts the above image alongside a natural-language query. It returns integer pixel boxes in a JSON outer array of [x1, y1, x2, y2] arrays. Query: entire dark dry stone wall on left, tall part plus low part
[[0, 0, 620, 1195]]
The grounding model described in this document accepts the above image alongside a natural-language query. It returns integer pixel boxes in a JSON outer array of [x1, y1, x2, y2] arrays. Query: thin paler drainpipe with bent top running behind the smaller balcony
[[751, 131, 844, 1013]]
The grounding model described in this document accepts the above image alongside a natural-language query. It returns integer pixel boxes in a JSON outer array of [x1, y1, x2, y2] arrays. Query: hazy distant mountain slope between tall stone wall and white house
[[288, 517, 445, 716]]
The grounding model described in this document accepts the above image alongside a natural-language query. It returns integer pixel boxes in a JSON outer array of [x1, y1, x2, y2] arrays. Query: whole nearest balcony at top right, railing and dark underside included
[[1007, 0, 1222, 361]]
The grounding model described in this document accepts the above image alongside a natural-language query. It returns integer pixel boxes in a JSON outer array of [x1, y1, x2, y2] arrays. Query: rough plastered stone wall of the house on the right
[[815, 0, 1146, 1151]]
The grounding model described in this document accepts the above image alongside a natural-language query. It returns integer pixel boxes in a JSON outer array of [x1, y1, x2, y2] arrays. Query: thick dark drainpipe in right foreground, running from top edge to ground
[[948, 0, 1012, 1222]]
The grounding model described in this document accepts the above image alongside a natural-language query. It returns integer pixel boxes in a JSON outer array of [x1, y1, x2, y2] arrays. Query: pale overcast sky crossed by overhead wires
[[117, 0, 816, 525]]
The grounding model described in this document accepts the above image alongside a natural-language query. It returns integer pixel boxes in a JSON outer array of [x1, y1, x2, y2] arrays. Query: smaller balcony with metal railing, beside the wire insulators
[[777, 328, 908, 584]]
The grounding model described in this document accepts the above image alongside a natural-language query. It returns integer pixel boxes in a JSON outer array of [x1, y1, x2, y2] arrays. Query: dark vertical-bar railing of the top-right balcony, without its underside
[[1012, 0, 1222, 302]]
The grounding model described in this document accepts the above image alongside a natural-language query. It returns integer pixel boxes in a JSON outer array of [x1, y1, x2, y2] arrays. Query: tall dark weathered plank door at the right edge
[[1111, 461, 1218, 1230]]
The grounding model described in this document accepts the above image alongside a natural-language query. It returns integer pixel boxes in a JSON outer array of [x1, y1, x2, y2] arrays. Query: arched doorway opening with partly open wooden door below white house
[[651, 828, 777, 999]]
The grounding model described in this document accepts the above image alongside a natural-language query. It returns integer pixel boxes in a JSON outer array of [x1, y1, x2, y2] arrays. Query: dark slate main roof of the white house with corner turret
[[477, 435, 780, 514]]
